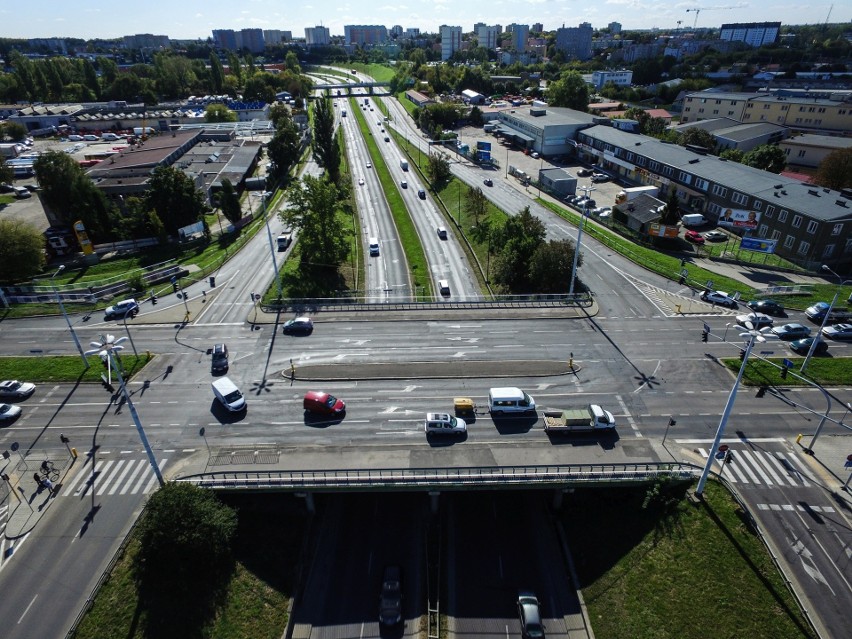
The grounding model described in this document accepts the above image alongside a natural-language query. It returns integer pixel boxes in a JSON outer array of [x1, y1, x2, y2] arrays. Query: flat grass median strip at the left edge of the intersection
[[0, 352, 154, 385]]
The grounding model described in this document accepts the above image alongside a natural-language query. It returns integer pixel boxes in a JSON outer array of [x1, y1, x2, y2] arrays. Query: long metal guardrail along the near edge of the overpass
[[175, 462, 700, 491]]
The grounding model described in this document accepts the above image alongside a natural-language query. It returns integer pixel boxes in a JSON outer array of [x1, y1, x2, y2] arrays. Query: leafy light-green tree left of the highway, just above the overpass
[[281, 175, 349, 270]]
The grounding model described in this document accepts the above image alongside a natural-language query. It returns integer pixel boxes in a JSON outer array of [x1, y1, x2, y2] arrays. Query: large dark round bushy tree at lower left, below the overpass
[[133, 482, 238, 637]]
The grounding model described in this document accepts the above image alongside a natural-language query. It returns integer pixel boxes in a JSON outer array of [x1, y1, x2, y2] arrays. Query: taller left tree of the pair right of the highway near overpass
[[492, 207, 547, 293]]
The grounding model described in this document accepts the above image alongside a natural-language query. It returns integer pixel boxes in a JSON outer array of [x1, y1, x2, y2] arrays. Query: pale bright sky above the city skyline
[[0, 0, 840, 39]]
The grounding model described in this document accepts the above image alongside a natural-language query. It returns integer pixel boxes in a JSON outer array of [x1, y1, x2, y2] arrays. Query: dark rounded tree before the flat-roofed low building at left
[[145, 166, 207, 235]]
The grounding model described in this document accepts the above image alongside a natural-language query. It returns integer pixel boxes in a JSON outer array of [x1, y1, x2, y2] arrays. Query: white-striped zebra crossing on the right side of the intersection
[[698, 446, 816, 486]]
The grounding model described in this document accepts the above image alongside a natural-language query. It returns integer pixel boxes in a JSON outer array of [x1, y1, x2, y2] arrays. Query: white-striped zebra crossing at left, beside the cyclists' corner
[[59, 458, 168, 497]]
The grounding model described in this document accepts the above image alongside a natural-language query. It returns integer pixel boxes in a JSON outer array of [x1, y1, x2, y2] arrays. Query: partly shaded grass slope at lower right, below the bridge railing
[[560, 482, 816, 639]]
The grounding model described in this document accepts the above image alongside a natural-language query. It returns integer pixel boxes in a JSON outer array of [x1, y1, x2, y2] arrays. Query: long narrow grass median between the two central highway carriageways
[[349, 98, 433, 299]]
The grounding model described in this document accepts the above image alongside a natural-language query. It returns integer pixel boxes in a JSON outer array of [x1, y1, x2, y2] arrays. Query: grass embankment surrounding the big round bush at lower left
[[72, 495, 307, 639]]
